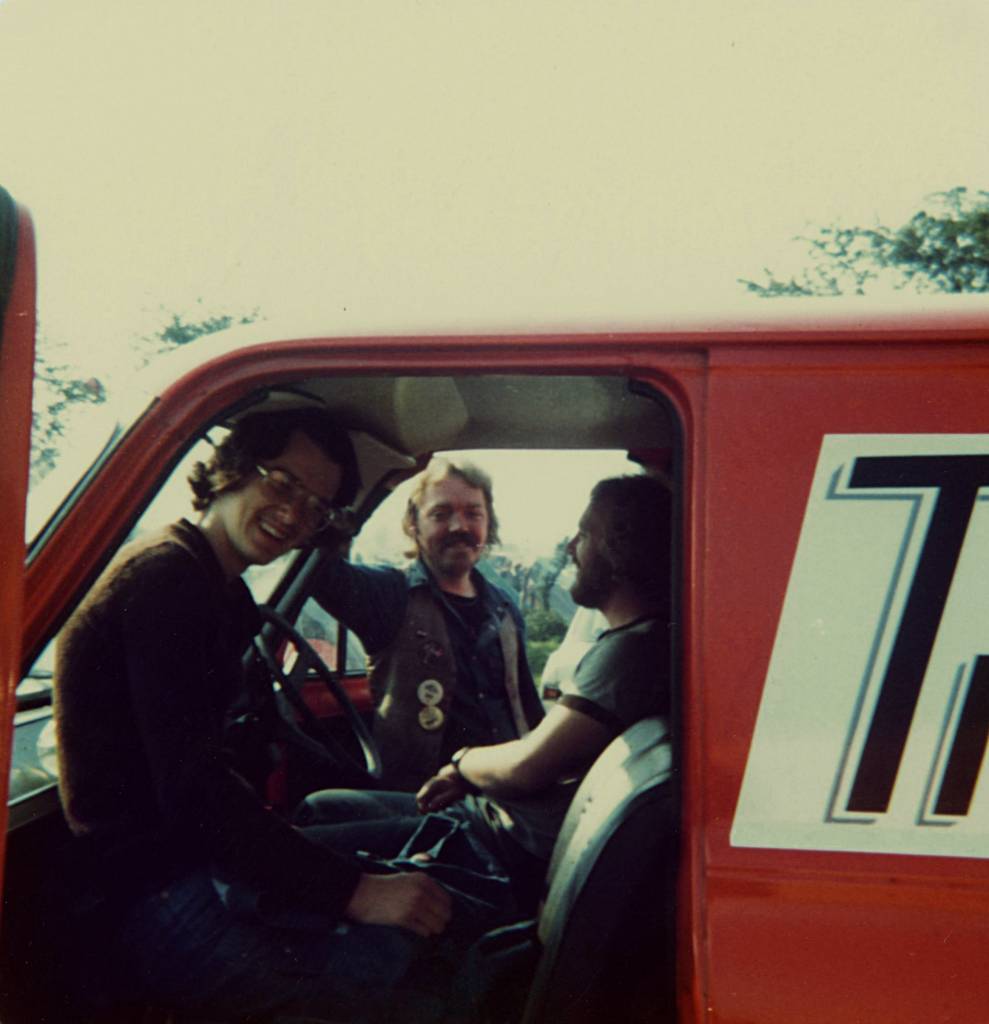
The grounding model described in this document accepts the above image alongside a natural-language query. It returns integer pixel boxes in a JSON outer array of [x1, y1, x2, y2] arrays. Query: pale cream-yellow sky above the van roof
[[0, 0, 989, 552]]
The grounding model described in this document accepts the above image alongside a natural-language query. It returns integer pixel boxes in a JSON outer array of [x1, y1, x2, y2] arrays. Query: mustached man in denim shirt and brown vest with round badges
[[309, 459, 543, 790]]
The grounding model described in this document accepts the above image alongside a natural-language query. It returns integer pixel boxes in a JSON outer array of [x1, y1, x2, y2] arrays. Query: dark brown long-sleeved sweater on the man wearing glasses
[[55, 520, 360, 915]]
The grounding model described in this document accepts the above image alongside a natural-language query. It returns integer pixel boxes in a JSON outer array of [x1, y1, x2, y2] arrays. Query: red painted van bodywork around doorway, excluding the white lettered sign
[[6, 314, 989, 1024]]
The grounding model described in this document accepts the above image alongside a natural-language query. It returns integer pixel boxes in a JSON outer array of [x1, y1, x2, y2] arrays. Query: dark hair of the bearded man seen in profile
[[591, 475, 674, 601]]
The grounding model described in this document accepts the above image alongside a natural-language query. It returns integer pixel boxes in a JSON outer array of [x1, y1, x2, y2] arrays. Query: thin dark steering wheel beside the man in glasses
[[256, 605, 383, 780]]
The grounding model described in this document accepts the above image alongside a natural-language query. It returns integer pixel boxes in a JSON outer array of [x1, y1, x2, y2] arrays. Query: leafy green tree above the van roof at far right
[[739, 186, 989, 298]]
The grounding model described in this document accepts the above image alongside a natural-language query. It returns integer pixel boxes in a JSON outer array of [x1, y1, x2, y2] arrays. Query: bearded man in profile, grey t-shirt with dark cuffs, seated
[[409, 475, 673, 910]]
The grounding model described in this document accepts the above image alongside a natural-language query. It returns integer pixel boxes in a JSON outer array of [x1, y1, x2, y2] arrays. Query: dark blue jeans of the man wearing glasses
[[96, 869, 425, 1024]]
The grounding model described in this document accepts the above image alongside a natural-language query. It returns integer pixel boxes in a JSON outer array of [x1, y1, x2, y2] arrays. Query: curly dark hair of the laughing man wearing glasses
[[188, 409, 360, 532]]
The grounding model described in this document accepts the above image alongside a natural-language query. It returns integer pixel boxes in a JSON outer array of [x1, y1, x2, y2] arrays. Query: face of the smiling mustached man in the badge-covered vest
[[413, 475, 488, 596]]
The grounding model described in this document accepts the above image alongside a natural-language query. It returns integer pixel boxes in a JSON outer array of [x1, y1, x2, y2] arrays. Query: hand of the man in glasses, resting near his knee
[[344, 872, 453, 938]]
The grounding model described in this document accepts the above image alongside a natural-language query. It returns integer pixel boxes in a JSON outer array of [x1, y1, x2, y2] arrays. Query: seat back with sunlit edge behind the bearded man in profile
[[523, 718, 678, 1024]]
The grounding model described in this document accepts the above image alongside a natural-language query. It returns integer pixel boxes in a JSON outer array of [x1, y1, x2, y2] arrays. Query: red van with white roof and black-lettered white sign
[[0, 190, 989, 1024]]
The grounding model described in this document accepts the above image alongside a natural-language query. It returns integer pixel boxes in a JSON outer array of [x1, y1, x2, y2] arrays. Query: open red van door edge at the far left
[[0, 188, 36, 882]]
